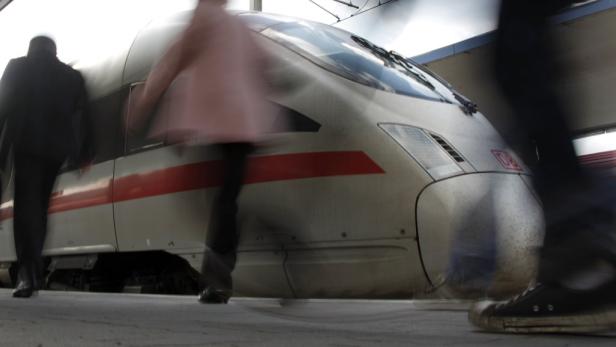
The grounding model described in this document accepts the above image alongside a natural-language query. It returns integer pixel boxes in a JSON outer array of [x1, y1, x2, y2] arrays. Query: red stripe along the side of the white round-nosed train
[[0, 152, 385, 220]]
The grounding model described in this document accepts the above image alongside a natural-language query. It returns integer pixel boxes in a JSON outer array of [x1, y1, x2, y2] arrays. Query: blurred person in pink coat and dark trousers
[[128, 0, 274, 303]]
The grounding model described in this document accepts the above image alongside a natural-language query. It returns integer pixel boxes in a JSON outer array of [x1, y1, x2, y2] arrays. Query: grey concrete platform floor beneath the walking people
[[0, 289, 616, 347]]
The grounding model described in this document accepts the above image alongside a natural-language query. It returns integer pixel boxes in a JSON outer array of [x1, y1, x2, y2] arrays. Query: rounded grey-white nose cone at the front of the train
[[416, 173, 544, 297]]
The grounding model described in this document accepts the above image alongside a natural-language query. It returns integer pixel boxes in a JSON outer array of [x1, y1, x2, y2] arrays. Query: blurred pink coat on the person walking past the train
[[141, 1, 275, 144]]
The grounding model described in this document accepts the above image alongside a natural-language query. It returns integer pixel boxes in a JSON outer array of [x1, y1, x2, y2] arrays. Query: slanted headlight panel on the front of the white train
[[379, 123, 464, 180]]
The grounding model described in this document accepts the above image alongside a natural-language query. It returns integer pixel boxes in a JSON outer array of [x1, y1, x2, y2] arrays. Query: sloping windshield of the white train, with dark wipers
[[262, 22, 457, 103]]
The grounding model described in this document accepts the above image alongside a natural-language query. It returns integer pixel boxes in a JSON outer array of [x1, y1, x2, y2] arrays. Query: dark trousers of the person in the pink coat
[[202, 143, 253, 290]]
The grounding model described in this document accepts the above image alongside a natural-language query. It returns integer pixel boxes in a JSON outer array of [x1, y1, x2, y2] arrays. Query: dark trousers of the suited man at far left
[[13, 153, 62, 284]]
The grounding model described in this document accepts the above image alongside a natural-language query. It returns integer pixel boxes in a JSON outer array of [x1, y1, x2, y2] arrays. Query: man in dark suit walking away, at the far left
[[0, 36, 91, 298]]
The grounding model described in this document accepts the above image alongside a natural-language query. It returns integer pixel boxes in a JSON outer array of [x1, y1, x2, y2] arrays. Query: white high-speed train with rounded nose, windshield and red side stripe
[[0, 12, 543, 298]]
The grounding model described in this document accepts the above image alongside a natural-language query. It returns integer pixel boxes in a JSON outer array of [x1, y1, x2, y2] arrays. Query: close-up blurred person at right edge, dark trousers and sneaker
[[469, 0, 616, 333]]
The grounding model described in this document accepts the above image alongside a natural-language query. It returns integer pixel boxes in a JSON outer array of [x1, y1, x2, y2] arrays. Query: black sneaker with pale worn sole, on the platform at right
[[468, 281, 616, 333]]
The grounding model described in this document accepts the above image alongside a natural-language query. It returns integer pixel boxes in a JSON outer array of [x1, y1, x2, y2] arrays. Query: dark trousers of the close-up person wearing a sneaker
[[494, 0, 616, 283]]
